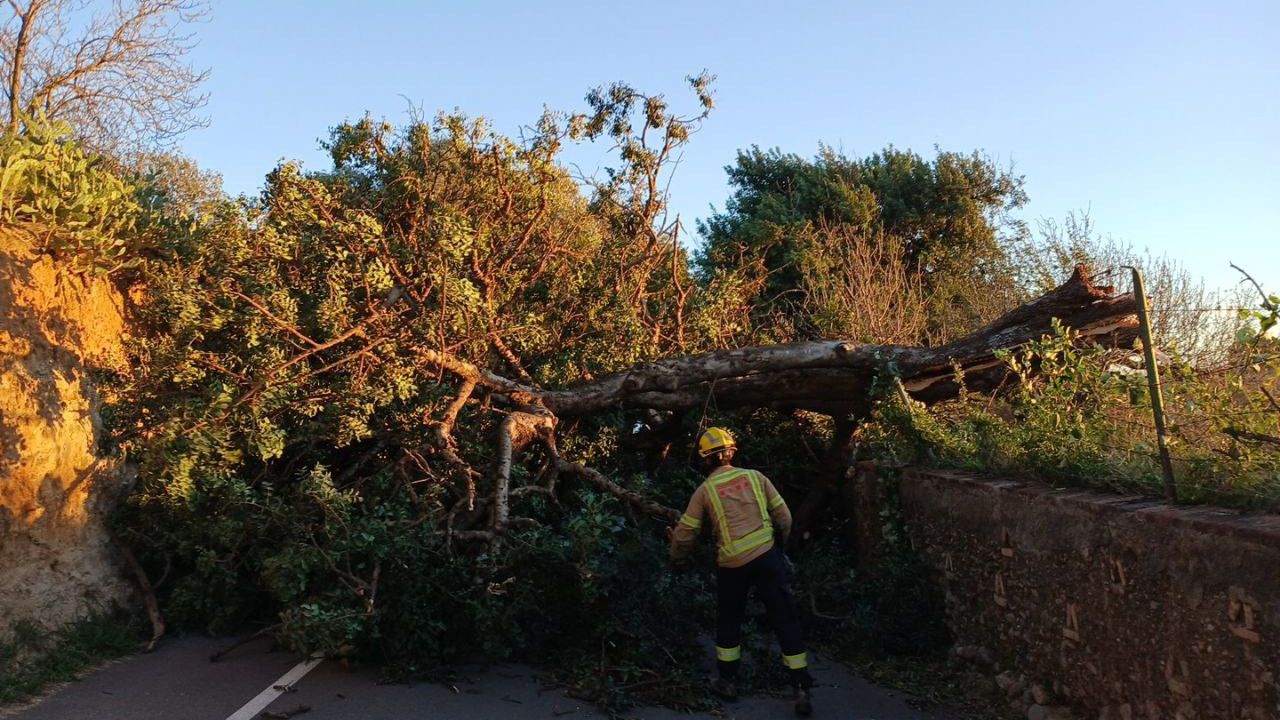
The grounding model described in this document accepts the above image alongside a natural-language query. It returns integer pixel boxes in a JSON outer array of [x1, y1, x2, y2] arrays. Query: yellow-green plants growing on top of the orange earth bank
[[0, 120, 142, 273]]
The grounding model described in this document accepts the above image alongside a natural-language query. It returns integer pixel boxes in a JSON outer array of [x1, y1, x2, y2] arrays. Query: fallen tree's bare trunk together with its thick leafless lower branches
[[407, 268, 1137, 539]]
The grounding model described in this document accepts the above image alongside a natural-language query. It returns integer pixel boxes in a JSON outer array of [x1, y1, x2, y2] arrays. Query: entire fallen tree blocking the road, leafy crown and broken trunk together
[[104, 94, 1134, 700]]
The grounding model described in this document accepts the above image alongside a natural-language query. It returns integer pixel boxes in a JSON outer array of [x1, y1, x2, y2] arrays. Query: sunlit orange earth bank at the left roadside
[[0, 231, 129, 637]]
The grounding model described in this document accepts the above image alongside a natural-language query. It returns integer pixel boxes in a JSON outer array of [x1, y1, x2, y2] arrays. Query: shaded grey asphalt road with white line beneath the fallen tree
[[0, 638, 943, 720]]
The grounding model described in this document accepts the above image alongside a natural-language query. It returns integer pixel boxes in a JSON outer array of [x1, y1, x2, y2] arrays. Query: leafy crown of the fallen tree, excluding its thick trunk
[[104, 83, 747, 707]]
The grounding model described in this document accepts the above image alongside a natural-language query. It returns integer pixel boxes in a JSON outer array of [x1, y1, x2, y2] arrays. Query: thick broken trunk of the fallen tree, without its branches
[[535, 268, 1137, 418]]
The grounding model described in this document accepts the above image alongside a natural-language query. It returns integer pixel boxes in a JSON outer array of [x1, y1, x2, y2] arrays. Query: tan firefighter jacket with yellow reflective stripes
[[671, 466, 791, 568]]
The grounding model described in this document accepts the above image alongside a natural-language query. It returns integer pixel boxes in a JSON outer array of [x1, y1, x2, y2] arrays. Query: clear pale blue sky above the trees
[[183, 0, 1280, 291]]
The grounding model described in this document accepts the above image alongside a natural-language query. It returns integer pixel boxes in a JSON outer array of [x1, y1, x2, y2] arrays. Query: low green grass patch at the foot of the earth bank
[[0, 612, 142, 705]]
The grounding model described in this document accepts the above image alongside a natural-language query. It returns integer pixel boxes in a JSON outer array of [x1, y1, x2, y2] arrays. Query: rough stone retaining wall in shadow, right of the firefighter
[[901, 470, 1280, 720]]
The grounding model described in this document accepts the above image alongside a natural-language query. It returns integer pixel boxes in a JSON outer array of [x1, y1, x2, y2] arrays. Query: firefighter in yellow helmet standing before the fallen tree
[[669, 428, 813, 717]]
